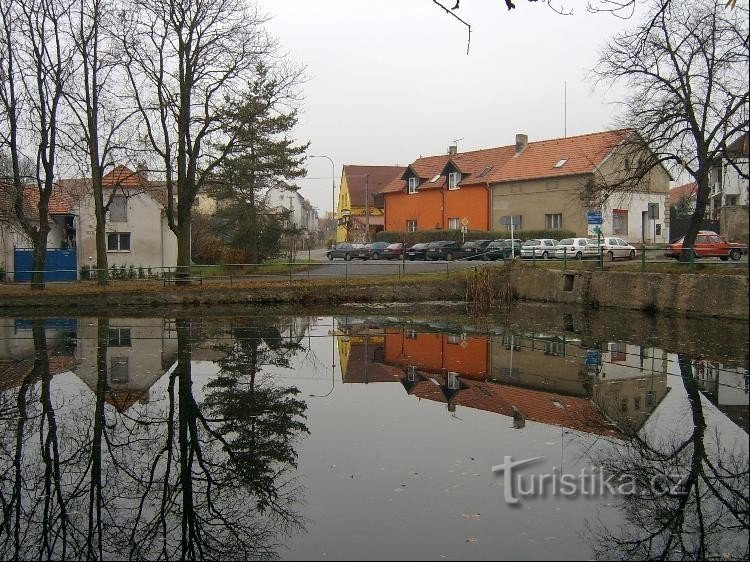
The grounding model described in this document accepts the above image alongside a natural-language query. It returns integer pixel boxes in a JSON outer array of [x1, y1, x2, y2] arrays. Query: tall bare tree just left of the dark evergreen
[[122, 0, 275, 281]]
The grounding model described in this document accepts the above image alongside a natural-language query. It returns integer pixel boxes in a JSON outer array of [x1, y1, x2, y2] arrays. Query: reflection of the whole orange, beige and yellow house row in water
[[339, 322, 668, 435]]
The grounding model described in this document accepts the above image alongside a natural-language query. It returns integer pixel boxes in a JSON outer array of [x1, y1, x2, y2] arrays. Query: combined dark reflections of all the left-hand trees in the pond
[[0, 318, 307, 560]]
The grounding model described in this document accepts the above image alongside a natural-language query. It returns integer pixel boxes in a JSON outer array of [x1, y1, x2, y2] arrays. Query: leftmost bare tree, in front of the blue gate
[[0, 0, 71, 289]]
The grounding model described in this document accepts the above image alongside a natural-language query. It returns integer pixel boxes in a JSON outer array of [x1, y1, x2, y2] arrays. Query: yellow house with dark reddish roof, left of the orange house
[[336, 165, 406, 242]]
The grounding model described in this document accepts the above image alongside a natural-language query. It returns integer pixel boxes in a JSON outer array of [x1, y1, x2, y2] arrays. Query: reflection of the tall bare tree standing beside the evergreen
[[123, 320, 308, 560]]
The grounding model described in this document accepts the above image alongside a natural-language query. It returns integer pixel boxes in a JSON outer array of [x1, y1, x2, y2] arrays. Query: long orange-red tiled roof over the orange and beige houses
[[383, 129, 631, 193]]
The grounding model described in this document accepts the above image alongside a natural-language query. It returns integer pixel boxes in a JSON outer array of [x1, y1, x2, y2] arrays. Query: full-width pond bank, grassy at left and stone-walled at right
[[0, 266, 749, 320]]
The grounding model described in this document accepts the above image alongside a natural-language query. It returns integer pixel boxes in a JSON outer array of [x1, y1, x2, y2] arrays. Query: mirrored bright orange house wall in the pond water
[[384, 328, 489, 380]]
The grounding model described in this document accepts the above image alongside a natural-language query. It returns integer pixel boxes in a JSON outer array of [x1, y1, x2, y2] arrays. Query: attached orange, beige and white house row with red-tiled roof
[[384, 130, 670, 243]]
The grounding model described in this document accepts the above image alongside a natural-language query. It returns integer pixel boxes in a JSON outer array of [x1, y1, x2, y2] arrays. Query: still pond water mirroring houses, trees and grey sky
[[0, 306, 748, 560]]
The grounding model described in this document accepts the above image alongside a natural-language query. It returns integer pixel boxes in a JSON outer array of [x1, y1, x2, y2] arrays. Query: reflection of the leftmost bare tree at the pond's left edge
[[0, 319, 69, 559]]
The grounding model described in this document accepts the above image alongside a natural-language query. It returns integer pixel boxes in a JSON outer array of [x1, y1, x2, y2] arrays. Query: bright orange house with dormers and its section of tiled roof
[[381, 146, 514, 232]]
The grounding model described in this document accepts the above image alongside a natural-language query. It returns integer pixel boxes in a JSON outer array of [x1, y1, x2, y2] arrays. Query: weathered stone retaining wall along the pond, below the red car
[[510, 267, 749, 319]]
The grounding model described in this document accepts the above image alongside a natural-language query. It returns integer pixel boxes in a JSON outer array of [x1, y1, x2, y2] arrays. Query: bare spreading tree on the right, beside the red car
[[592, 0, 750, 260]]
